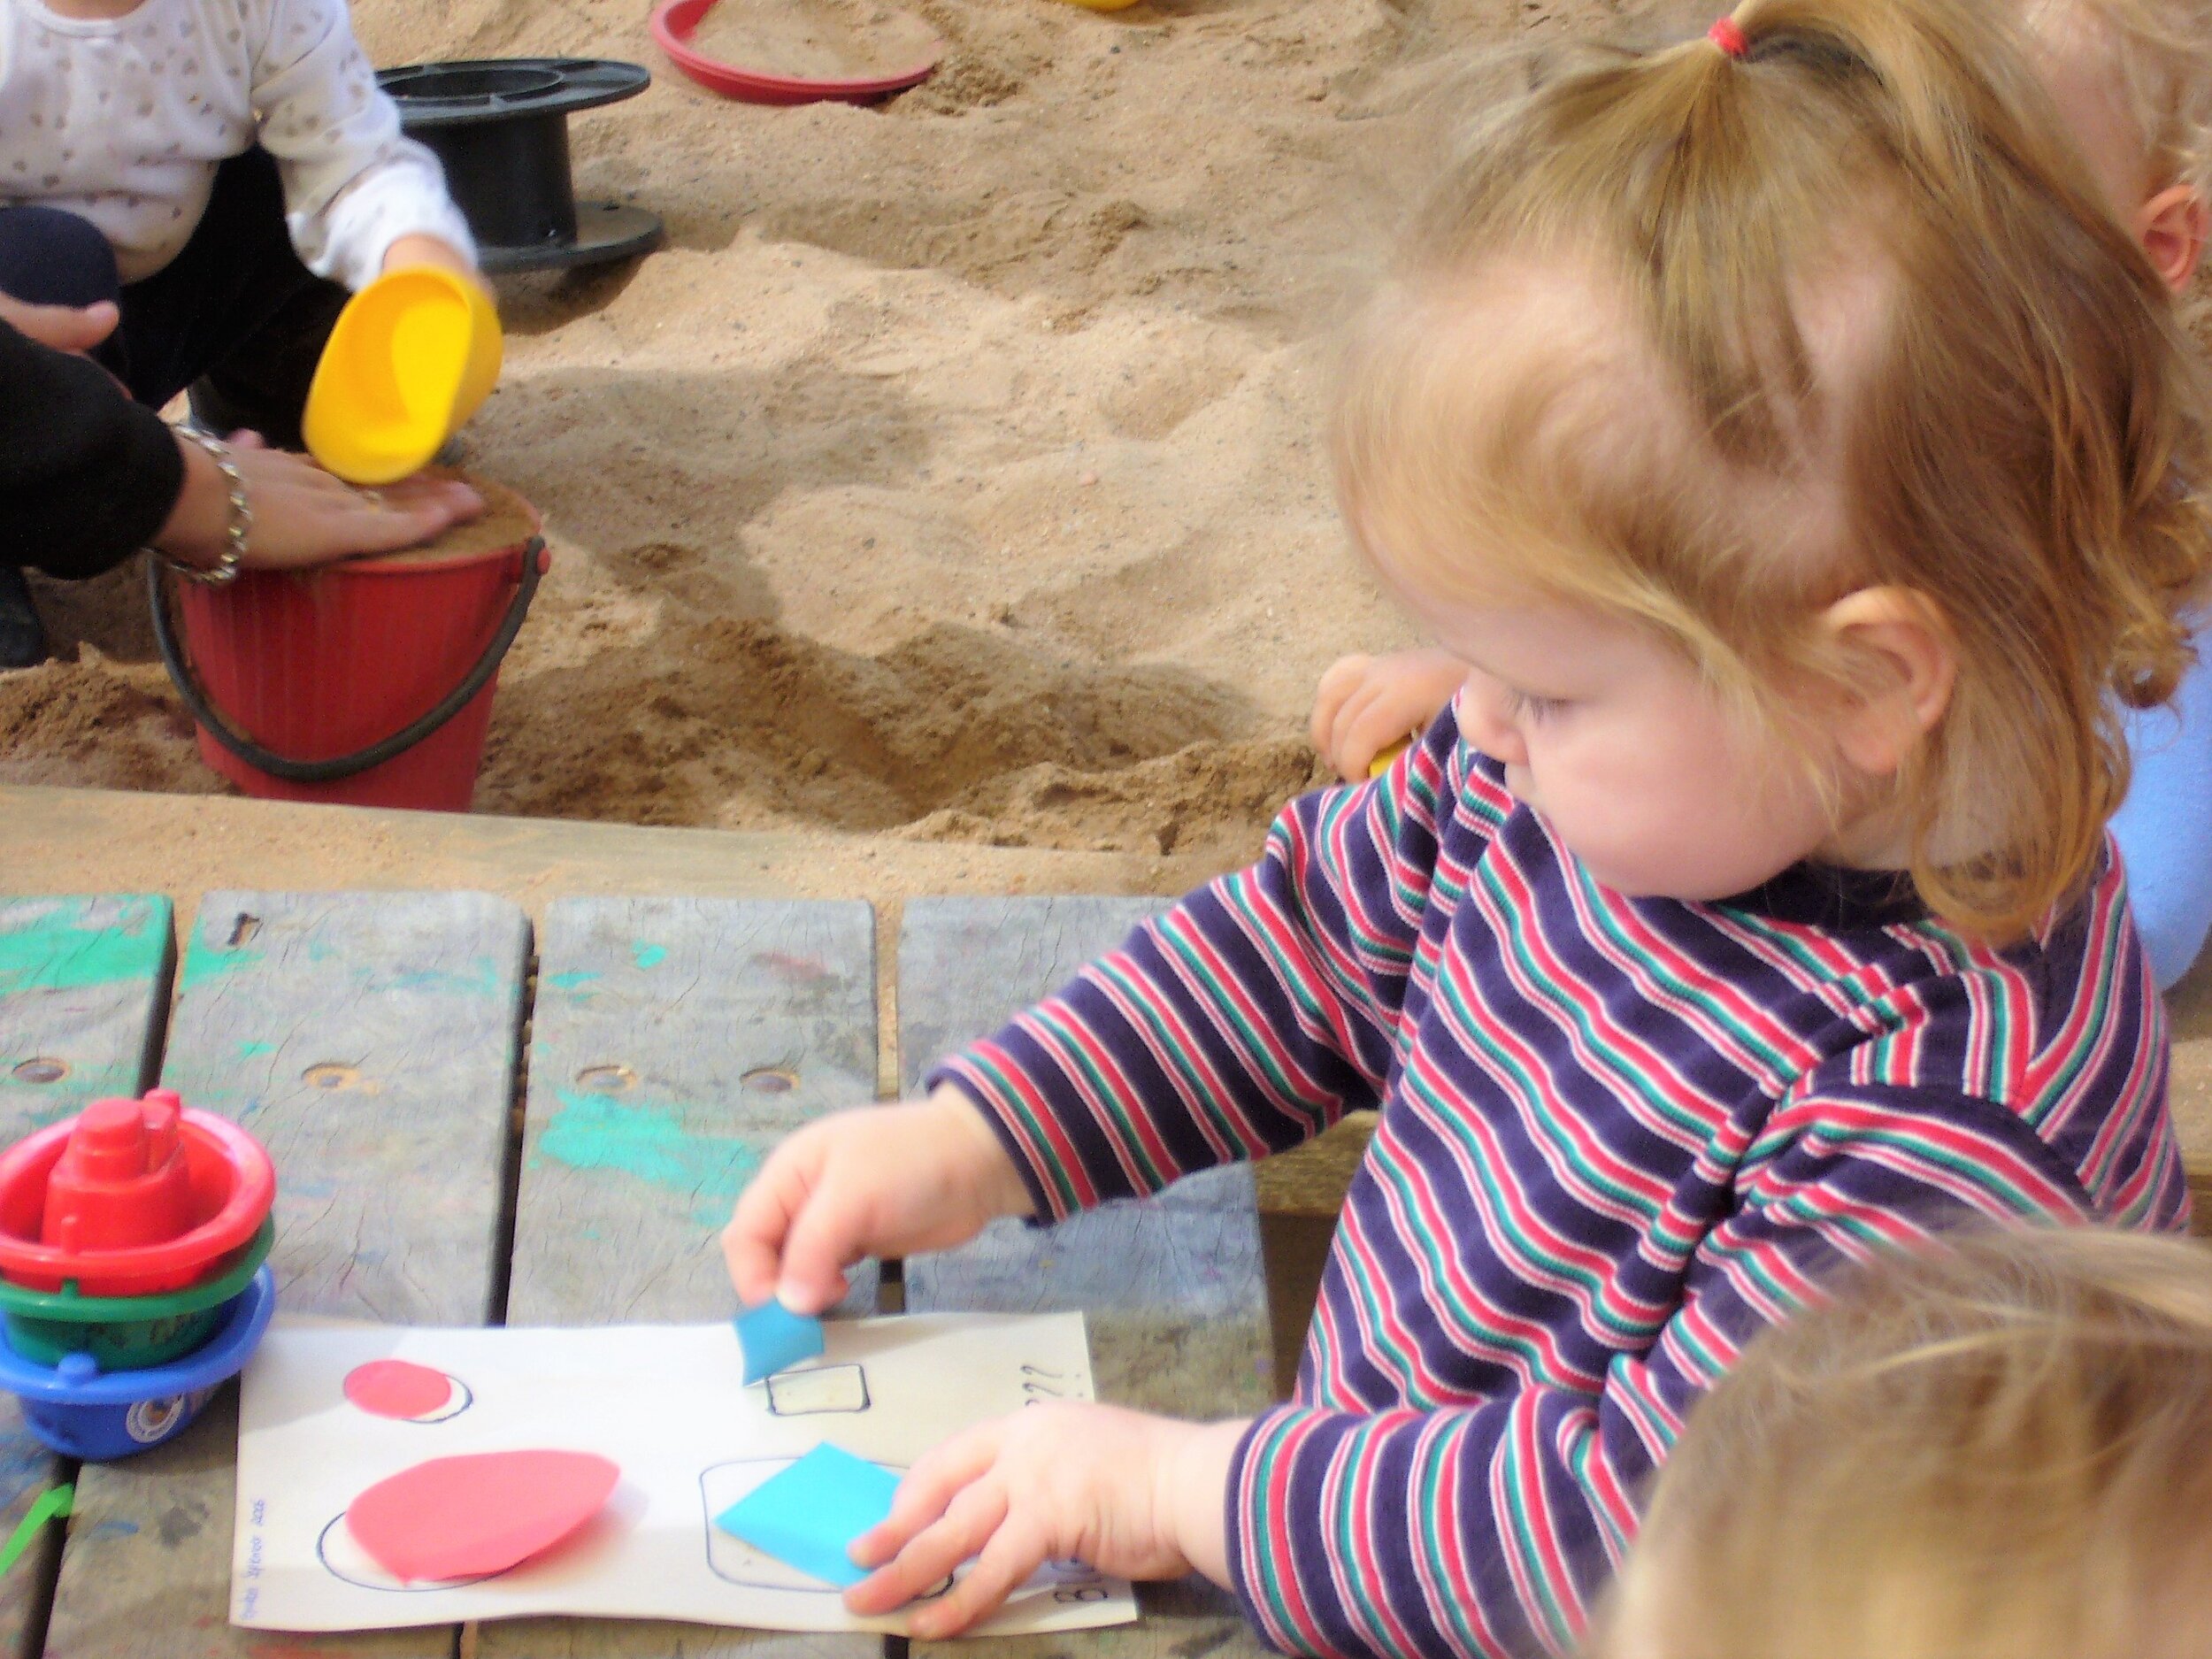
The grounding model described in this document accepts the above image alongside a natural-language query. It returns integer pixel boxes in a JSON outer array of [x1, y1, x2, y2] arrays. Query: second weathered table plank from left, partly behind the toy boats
[[47, 892, 529, 1659]]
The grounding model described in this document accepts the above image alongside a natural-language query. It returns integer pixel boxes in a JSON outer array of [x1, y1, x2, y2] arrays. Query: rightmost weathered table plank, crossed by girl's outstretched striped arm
[[898, 898, 1272, 1659]]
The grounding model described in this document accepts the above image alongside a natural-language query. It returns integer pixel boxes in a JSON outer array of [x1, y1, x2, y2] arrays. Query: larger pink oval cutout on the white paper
[[345, 1451, 622, 1584]]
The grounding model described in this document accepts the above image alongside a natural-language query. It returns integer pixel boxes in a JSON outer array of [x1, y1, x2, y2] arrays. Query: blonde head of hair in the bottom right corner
[[1588, 1230, 2212, 1659]]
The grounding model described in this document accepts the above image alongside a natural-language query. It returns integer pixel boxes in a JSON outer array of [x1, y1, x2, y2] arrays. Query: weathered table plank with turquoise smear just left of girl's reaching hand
[[476, 898, 883, 1659]]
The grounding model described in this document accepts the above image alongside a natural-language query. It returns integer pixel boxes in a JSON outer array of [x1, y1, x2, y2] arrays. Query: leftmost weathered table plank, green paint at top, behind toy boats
[[0, 894, 177, 1655]]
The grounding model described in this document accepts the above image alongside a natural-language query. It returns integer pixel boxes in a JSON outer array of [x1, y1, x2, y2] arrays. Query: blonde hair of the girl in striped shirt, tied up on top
[[1334, 0, 2212, 938]]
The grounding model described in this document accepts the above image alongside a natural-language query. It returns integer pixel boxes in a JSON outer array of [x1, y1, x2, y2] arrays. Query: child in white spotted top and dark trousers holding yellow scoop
[[0, 0, 476, 666]]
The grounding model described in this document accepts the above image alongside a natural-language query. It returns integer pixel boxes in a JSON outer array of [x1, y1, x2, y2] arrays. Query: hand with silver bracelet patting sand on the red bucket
[[153, 432, 485, 571]]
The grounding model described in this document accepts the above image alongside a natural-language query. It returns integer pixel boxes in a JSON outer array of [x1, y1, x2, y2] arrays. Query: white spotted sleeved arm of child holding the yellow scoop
[[255, 0, 476, 288]]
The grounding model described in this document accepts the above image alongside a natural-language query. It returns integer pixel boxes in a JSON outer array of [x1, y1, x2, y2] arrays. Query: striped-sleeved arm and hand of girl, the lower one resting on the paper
[[849, 1088, 2181, 1659]]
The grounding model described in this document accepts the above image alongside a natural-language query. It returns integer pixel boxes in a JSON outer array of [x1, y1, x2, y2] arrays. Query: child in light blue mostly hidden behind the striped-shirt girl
[[1312, 0, 2212, 987]]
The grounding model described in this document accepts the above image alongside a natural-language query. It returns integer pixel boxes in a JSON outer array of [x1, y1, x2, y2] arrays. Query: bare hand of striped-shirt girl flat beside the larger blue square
[[845, 1405, 1246, 1641]]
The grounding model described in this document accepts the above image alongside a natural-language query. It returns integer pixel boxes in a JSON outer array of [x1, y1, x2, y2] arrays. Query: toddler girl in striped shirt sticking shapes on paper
[[726, 0, 2212, 1655]]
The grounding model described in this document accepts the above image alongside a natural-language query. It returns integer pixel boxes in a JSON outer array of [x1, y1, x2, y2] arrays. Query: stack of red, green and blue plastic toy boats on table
[[0, 1088, 277, 1458]]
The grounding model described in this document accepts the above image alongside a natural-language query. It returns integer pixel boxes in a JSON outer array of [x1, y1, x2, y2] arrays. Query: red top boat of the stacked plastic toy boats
[[0, 1088, 277, 1296]]
